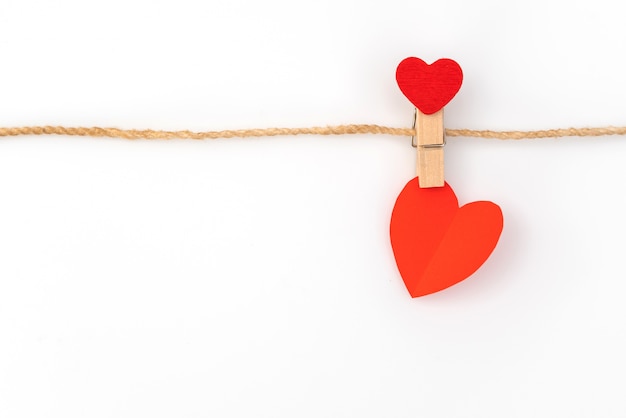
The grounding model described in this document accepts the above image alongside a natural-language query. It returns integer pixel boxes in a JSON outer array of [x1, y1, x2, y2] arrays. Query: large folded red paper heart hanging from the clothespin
[[390, 177, 503, 297]]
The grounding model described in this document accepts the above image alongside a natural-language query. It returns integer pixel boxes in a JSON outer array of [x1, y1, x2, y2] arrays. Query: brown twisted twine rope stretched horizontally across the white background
[[0, 125, 626, 139]]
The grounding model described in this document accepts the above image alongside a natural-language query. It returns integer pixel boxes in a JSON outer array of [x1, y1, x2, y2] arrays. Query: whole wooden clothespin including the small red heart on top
[[396, 57, 463, 188]]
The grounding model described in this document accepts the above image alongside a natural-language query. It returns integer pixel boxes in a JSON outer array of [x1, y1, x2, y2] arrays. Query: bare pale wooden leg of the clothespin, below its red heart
[[415, 109, 445, 188]]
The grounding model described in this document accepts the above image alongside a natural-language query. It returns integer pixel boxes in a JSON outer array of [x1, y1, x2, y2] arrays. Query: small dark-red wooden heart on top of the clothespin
[[396, 57, 463, 115]]
